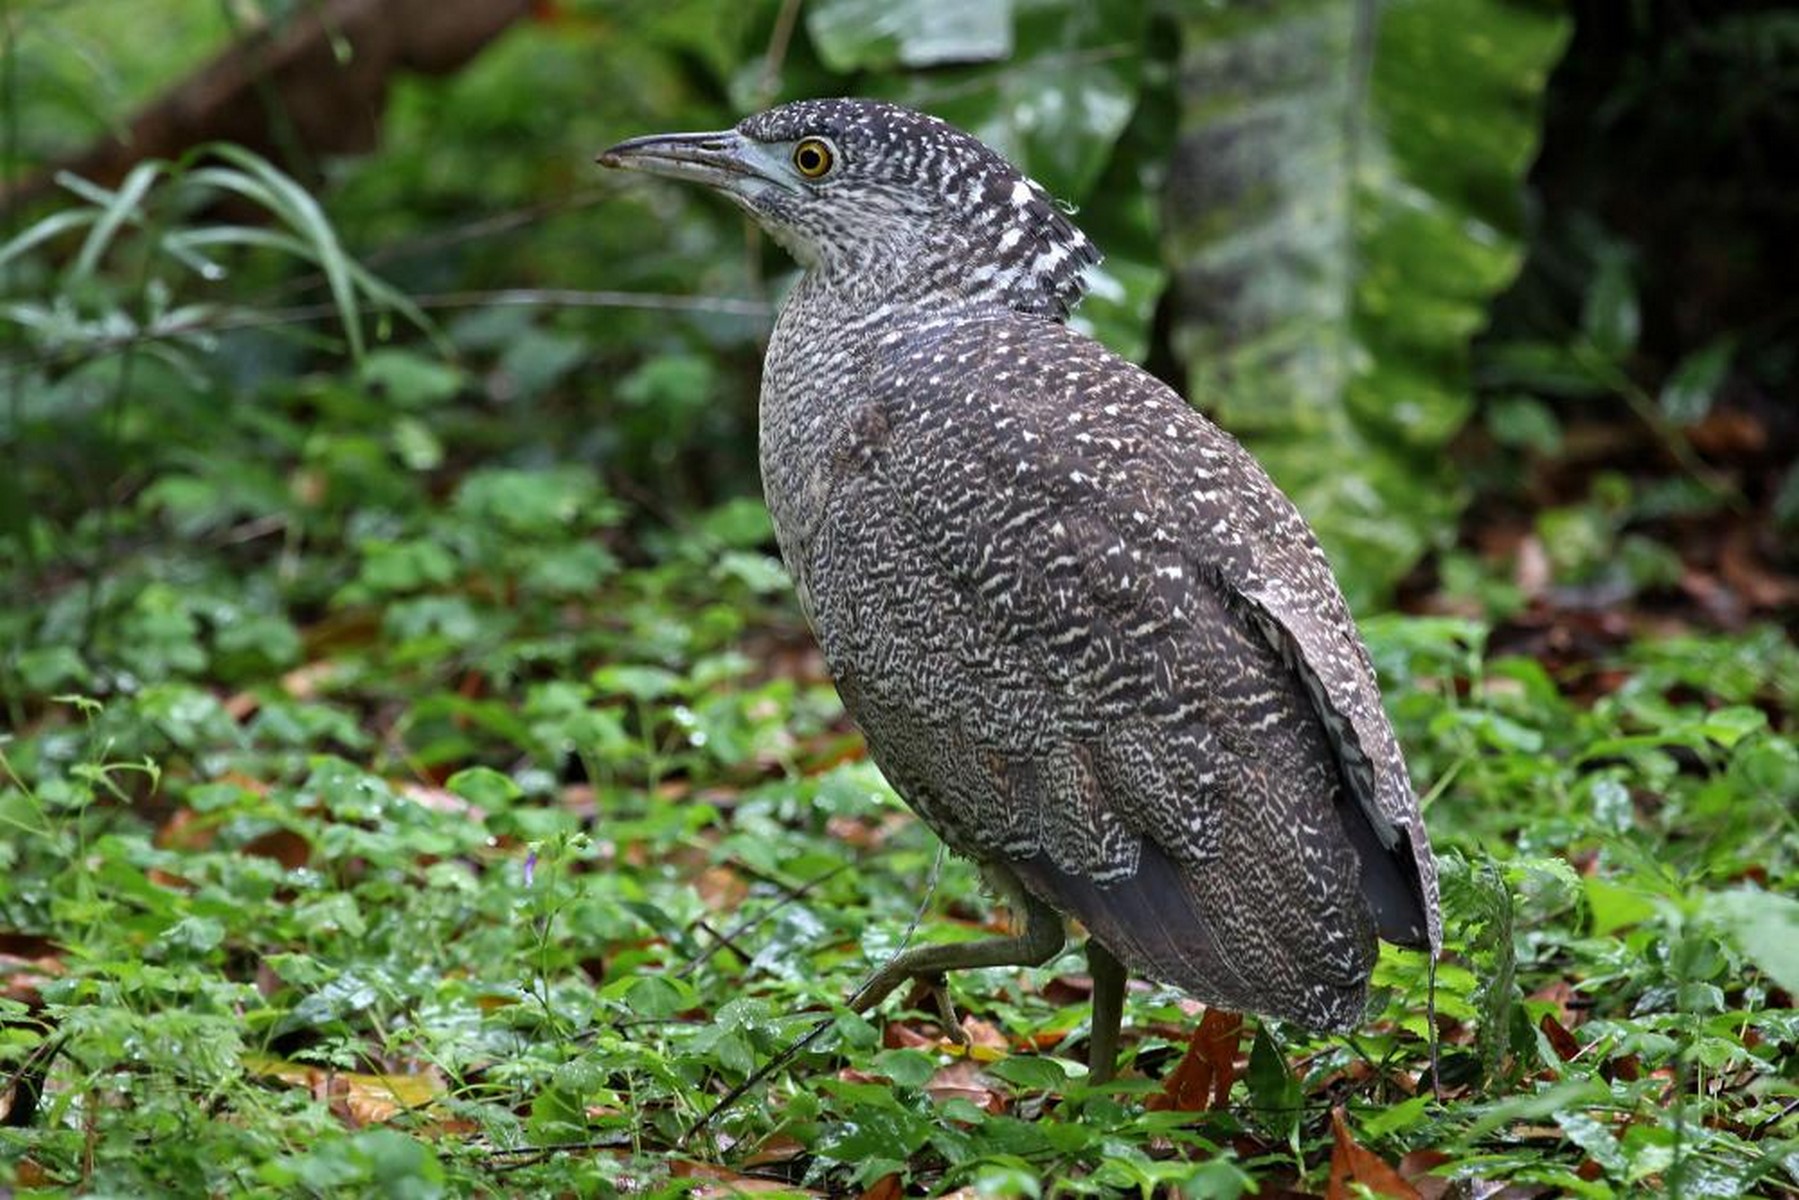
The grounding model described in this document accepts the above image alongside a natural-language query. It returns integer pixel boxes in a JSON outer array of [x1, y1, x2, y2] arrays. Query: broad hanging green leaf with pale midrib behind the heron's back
[[1164, 0, 1567, 604]]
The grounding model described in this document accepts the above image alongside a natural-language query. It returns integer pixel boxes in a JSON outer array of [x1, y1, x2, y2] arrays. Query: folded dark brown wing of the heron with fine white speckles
[[802, 313, 1439, 1027]]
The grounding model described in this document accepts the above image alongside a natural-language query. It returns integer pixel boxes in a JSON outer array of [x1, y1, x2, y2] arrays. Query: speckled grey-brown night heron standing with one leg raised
[[599, 99, 1441, 1079]]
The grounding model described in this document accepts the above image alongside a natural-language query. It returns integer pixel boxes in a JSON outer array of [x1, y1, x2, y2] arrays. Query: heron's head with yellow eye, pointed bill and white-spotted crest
[[599, 99, 1099, 320]]
